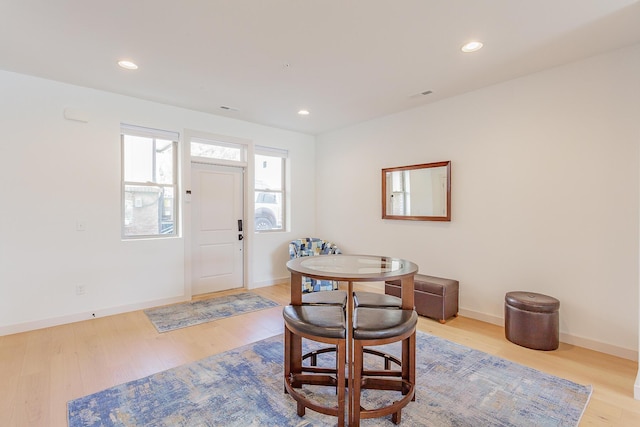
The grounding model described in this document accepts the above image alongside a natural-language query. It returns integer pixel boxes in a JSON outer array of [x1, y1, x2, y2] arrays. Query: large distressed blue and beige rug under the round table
[[68, 332, 591, 427]]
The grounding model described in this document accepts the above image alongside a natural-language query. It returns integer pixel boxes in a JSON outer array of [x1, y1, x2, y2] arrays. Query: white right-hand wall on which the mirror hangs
[[317, 45, 640, 358]]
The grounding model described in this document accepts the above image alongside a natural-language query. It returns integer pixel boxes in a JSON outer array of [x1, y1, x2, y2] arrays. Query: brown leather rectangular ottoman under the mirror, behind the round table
[[384, 274, 460, 323]]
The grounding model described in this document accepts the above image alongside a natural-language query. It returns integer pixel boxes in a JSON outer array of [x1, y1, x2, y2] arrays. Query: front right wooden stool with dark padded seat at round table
[[351, 307, 418, 426]]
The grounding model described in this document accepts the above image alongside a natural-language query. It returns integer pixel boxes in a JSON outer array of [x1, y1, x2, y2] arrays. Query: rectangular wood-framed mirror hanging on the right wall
[[382, 161, 451, 221]]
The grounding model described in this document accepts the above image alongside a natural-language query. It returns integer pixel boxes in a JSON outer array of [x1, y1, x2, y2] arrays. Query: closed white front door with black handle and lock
[[191, 163, 244, 295]]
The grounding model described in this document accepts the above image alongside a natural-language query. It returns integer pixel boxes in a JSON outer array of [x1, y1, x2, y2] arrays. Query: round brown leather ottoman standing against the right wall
[[504, 291, 560, 350]]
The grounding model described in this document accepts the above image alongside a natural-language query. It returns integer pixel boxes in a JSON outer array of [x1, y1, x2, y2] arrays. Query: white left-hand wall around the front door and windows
[[0, 71, 315, 335]]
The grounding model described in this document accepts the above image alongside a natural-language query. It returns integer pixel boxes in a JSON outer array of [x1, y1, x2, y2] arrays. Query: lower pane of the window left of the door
[[124, 185, 175, 237]]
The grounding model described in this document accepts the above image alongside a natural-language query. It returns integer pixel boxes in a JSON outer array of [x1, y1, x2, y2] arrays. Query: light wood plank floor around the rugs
[[0, 285, 640, 427]]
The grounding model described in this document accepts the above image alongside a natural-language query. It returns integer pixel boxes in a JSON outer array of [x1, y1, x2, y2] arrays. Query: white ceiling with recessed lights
[[0, 0, 640, 134]]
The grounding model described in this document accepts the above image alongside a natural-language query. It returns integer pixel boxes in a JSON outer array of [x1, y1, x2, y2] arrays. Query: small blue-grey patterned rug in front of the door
[[144, 292, 279, 332]]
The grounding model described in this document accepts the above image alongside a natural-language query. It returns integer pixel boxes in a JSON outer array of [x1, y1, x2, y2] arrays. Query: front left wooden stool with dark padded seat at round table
[[282, 304, 347, 427]]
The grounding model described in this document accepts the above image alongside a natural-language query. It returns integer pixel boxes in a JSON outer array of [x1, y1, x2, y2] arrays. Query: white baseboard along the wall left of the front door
[[0, 296, 191, 336]]
